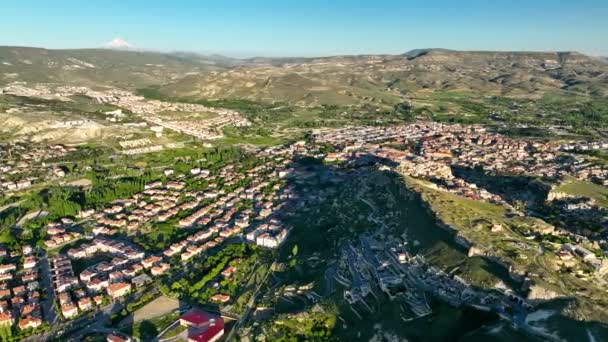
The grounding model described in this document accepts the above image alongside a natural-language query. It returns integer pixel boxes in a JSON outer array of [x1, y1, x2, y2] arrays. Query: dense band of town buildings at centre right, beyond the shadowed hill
[[315, 123, 608, 184]]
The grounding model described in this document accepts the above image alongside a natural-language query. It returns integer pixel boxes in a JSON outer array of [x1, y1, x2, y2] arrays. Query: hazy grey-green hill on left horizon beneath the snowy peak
[[0, 47, 229, 88]]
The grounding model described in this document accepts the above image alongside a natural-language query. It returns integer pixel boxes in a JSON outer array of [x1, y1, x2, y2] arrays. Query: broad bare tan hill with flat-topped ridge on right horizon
[[157, 49, 608, 104]]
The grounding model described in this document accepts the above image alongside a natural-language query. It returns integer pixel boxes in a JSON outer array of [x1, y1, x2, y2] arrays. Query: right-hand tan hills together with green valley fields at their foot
[[153, 49, 608, 135]]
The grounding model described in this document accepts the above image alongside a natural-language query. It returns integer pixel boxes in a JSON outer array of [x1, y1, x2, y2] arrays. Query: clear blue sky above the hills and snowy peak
[[0, 0, 608, 57]]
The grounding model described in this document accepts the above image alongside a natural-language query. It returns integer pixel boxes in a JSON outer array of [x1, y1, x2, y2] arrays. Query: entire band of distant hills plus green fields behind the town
[[0, 47, 608, 136]]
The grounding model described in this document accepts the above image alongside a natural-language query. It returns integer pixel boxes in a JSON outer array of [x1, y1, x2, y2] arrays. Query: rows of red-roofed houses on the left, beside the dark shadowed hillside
[[9, 149, 300, 324]]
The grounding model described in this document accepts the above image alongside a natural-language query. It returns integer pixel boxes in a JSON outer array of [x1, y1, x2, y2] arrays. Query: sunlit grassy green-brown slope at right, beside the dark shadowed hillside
[[406, 177, 608, 321]]
